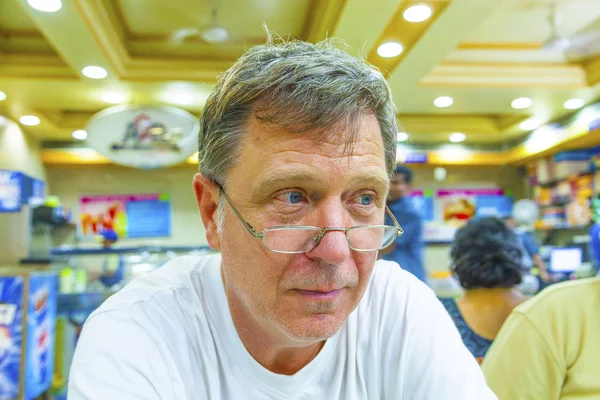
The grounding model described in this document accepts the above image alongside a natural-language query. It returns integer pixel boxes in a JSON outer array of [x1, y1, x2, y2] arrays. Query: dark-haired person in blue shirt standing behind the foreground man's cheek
[[381, 165, 427, 282]]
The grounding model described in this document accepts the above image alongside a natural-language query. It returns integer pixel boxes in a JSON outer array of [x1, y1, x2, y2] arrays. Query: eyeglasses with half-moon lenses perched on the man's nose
[[216, 183, 404, 254]]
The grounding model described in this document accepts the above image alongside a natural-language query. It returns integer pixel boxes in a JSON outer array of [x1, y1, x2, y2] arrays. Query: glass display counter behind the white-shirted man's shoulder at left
[[50, 246, 215, 399]]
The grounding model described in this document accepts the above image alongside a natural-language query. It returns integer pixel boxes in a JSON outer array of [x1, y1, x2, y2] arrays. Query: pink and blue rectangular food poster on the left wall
[[79, 194, 171, 238]]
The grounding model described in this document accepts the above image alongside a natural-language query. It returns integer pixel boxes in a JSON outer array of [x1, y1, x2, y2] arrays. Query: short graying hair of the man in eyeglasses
[[198, 36, 398, 230]]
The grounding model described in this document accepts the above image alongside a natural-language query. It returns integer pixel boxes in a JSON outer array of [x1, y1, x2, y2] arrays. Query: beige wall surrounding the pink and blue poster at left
[[46, 165, 206, 246]]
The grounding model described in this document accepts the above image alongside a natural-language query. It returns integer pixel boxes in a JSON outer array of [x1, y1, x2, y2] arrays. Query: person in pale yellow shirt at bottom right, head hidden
[[482, 278, 600, 400]]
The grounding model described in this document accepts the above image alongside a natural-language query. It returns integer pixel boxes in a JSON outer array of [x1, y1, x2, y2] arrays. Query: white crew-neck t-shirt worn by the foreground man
[[68, 255, 496, 400]]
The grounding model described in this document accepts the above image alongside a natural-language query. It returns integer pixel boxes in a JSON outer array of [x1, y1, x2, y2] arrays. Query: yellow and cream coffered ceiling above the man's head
[[0, 0, 600, 146]]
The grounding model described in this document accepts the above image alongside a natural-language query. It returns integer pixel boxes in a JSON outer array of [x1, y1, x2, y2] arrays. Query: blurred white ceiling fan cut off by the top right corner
[[543, 3, 600, 60]]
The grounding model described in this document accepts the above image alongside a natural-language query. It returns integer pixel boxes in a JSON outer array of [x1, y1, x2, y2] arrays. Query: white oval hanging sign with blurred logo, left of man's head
[[85, 106, 200, 169]]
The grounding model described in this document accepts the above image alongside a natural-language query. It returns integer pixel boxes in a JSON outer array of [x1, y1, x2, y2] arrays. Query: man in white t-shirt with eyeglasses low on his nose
[[69, 36, 495, 400]]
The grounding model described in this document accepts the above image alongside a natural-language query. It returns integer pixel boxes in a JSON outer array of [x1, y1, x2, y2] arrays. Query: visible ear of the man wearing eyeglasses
[[193, 174, 221, 250]]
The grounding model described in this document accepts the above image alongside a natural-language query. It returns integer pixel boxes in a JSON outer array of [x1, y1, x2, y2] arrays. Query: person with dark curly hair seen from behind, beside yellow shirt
[[440, 217, 529, 362]]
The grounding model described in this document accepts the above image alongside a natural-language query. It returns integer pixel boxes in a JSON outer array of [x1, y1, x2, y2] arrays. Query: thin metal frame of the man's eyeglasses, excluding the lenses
[[213, 182, 404, 254]]
